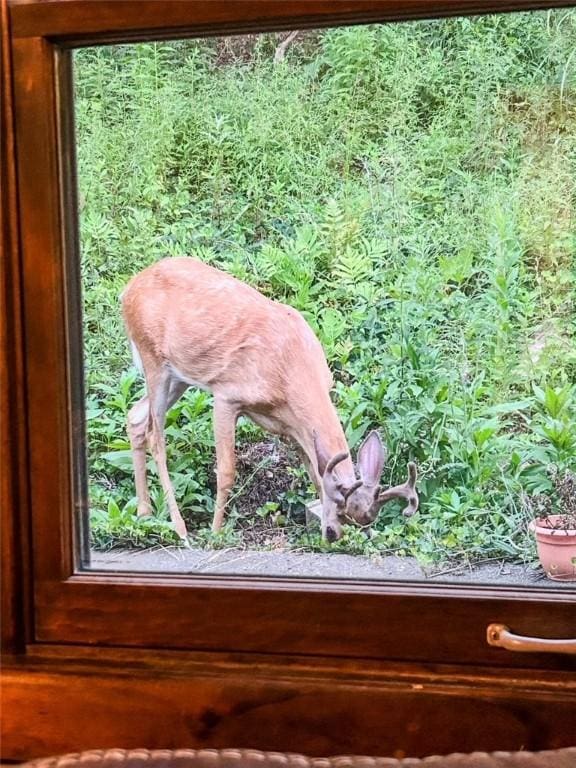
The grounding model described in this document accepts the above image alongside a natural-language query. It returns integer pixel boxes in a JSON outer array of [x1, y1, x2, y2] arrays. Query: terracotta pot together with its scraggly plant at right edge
[[528, 471, 576, 581]]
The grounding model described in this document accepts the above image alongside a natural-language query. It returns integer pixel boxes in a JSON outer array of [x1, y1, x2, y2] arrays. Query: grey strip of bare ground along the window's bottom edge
[[90, 547, 574, 589]]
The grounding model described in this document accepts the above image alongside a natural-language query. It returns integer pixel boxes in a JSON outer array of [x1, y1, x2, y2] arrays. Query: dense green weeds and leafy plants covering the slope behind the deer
[[75, 10, 576, 562]]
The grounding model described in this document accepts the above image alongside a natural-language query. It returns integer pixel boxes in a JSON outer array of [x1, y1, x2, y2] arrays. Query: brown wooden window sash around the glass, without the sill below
[[4, 0, 576, 670]]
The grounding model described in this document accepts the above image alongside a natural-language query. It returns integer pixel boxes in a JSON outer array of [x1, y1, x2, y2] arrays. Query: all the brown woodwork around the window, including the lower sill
[[0, 0, 576, 760]]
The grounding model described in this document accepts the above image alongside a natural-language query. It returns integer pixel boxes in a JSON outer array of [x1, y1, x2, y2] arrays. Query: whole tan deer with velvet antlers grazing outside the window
[[121, 257, 419, 542]]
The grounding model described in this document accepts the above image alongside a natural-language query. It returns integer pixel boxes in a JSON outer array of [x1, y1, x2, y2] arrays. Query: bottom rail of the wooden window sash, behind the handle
[[36, 574, 576, 670]]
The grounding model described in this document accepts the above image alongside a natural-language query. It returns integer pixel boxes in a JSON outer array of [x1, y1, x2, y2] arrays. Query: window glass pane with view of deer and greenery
[[74, 10, 576, 588]]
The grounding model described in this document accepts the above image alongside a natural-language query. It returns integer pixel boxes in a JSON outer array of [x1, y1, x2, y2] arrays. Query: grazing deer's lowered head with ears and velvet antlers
[[315, 431, 419, 541]]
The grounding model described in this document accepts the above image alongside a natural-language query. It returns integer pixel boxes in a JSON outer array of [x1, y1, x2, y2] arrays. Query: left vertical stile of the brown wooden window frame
[[13, 38, 73, 592]]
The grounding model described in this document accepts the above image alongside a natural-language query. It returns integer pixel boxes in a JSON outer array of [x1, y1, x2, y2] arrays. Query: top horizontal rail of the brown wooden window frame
[[10, 0, 573, 45]]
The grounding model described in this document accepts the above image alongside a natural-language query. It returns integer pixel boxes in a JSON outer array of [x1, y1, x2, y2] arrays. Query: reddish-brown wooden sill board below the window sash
[[2, 649, 576, 759]]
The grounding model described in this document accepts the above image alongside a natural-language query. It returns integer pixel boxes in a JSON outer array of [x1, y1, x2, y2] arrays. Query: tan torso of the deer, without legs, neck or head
[[122, 258, 331, 403]]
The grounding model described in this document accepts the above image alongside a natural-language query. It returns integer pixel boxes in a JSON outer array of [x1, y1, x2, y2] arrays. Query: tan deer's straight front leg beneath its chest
[[212, 397, 238, 532]]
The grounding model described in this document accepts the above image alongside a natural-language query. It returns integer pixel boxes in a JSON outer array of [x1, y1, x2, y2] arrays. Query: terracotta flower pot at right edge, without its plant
[[529, 515, 576, 581]]
